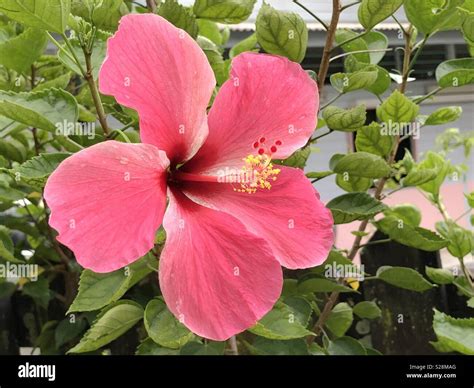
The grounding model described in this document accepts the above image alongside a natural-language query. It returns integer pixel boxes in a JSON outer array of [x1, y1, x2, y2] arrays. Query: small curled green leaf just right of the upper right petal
[[323, 104, 366, 132]]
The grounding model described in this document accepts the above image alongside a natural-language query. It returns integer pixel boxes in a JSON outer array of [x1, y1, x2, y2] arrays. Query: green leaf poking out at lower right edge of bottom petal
[[248, 302, 313, 340]]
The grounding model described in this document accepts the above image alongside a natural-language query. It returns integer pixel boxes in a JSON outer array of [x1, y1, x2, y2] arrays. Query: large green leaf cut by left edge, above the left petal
[[0, 89, 78, 132]]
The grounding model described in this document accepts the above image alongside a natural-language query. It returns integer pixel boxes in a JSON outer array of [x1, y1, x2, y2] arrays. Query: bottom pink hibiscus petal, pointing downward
[[159, 188, 282, 341]]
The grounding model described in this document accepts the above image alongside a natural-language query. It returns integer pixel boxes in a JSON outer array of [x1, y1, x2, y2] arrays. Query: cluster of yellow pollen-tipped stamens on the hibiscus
[[234, 154, 281, 194]]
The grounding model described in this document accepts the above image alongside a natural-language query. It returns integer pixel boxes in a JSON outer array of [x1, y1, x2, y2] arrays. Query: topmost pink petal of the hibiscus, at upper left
[[99, 14, 215, 164]]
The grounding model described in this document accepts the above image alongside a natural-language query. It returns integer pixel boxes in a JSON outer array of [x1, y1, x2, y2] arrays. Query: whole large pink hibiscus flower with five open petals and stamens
[[45, 14, 333, 340]]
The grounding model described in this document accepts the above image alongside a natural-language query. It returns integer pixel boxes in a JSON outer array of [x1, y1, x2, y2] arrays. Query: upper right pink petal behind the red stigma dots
[[185, 53, 319, 175]]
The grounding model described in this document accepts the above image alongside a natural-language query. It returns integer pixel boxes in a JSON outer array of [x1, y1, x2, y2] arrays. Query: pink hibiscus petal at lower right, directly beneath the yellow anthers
[[183, 167, 334, 269]]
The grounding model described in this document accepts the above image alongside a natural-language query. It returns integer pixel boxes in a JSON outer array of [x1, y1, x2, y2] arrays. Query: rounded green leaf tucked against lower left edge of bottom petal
[[145, 299, 194, 349]]
